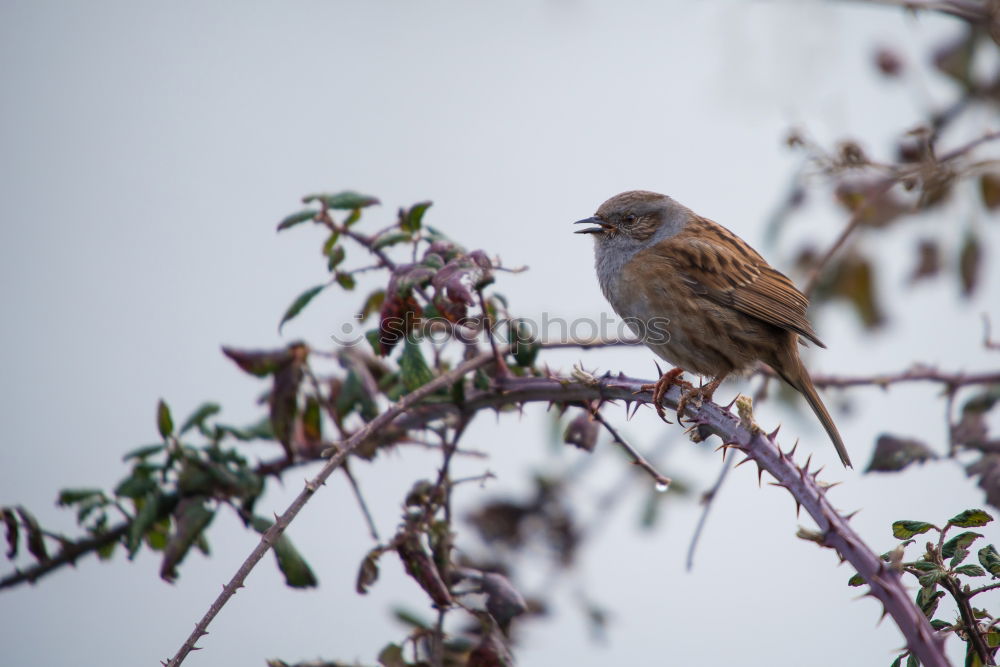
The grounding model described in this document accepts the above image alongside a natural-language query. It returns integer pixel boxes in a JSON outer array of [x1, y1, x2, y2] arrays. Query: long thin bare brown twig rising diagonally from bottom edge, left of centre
[[164, 353, 493, 667]]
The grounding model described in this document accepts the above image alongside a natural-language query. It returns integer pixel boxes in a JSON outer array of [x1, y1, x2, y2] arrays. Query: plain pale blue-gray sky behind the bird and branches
[[0, 0, 1000, 665]]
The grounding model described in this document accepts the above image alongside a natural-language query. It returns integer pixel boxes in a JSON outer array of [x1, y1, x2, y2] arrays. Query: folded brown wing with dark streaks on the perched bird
[[651, 219, 826, 347]]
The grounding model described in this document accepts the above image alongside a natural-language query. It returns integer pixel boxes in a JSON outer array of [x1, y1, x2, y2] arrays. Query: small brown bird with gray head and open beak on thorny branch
[[576, 190, 851, 467]]
